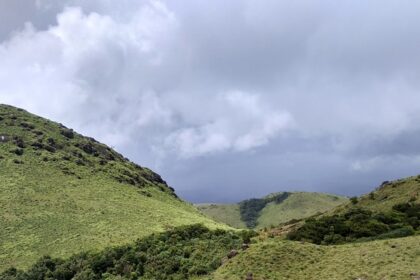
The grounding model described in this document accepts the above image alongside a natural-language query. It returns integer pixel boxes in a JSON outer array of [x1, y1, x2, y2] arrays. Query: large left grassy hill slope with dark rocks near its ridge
[[0, 105, 224, 270]]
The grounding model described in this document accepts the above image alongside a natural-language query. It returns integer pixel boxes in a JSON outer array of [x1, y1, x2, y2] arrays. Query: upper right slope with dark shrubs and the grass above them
[[288, 177, 420, 244]]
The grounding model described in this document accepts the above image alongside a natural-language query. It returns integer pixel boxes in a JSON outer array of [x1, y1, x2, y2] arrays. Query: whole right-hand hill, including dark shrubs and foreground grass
[[202, 176, 420, 280]]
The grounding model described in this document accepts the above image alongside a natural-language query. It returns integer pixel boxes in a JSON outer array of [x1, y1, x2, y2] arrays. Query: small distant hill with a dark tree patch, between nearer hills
[[196, 192, 348, 229]]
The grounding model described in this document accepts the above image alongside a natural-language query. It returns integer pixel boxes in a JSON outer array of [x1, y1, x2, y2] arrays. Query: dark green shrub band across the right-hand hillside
[[288, 203, 420, 244]]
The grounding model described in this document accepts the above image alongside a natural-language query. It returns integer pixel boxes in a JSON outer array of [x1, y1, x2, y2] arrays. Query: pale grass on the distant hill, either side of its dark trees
[[196, 192, 348, 229]]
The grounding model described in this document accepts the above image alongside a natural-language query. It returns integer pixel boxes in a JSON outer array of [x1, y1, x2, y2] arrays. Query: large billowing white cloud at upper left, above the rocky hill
[[0, 2, 176, 149]]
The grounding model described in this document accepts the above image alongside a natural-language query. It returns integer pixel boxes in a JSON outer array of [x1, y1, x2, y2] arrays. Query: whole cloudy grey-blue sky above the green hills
[[0, 0, 420, 202]]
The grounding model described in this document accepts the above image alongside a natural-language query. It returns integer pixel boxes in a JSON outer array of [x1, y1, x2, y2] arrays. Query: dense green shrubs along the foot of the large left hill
[[0, 225, 249, 280]]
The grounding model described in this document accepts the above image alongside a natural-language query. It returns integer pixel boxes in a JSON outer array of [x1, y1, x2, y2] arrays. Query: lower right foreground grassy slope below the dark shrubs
[[208, 236, 420, 280]]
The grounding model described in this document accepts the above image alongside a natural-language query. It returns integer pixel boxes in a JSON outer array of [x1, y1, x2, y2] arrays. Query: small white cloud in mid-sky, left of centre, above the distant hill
[[165, 91, 293, 158]]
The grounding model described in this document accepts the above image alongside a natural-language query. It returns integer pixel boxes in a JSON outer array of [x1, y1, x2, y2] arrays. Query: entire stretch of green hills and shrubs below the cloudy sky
[[0, 105, 420, 280]]
